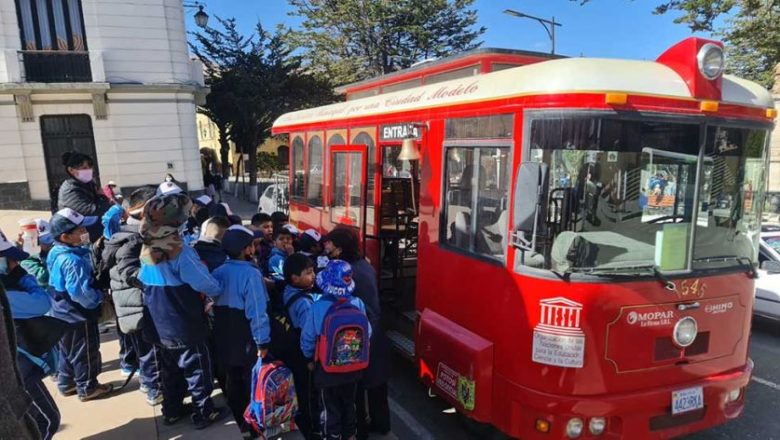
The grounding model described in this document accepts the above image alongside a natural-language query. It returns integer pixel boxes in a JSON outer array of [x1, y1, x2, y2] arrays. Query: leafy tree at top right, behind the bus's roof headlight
[[572, 0, 780, 88]]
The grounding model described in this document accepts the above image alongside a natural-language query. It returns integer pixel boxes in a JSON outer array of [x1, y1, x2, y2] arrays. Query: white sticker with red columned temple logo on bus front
[[531, 297, 585, 368]]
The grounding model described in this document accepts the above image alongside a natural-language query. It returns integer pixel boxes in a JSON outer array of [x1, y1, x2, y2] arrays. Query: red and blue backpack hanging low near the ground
[[244, 359, 298, 438]]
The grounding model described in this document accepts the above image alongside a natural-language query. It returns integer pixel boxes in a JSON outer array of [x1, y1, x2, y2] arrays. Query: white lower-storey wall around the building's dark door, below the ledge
[[0, 93, 203, 200]]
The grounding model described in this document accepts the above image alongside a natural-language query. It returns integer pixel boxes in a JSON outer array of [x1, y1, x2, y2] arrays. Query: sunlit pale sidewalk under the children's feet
[[44, 326, 241, 440]]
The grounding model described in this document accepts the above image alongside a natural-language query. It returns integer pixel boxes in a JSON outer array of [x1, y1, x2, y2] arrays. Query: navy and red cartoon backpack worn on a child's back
[[314, 298, 369, 373]]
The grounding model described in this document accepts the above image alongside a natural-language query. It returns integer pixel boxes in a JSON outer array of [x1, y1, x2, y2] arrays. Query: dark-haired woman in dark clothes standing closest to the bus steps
[[323, 228, 390, 440]]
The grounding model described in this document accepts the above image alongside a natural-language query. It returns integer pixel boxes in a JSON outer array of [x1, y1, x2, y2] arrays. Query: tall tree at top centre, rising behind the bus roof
[[289, 0, 485, 84]]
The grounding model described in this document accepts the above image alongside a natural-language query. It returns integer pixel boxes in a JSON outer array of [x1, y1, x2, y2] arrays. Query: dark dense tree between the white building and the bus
[[191, 17, 335, 189]]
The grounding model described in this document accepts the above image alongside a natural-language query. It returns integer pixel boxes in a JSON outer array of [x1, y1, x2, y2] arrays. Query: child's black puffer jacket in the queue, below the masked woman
[[103, 225, 144, 333]]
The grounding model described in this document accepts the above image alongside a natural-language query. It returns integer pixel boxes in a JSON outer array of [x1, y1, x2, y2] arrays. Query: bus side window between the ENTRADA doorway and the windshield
[[442, 115, 512, 261]]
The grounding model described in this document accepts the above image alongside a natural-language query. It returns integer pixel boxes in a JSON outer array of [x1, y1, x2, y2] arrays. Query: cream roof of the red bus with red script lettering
[[274, 58, 774, 133]]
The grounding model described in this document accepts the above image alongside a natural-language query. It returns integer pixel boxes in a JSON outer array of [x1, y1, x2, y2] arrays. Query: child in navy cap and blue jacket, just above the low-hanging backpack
[[214, 225, 271, 425]]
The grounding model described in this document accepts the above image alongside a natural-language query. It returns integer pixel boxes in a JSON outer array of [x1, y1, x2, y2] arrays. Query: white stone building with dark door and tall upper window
[[0, 0, 207, 208]]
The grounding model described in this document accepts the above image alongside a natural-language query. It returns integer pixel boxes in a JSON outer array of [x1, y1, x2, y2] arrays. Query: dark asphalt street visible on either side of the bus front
[[390, 319, 780, 440]]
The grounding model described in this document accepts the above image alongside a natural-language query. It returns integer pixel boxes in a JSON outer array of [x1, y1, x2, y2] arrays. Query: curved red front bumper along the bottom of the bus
[[493, 359, 753, 440]]
